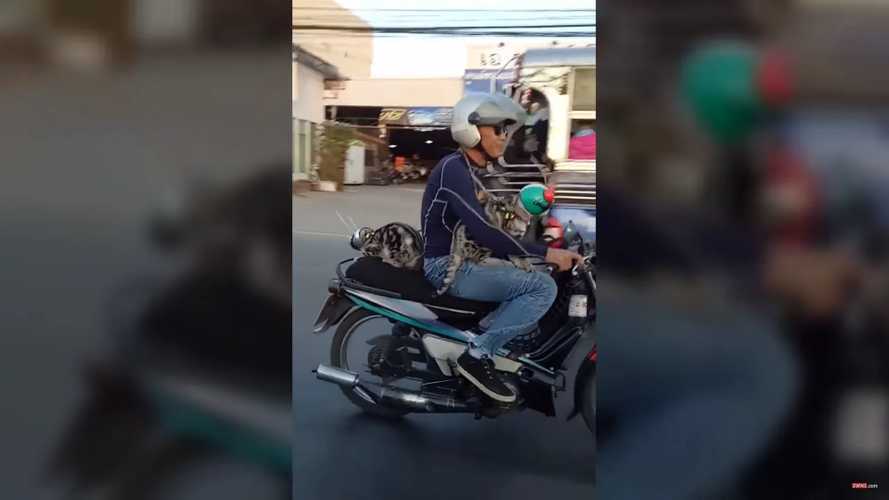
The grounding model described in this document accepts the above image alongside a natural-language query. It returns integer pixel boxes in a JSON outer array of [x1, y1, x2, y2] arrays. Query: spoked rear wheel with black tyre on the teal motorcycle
[[330, 309, 420, 418]]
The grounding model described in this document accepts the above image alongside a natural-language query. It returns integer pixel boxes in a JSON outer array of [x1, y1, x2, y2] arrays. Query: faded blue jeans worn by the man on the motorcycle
[[423, 256, 558, 357]]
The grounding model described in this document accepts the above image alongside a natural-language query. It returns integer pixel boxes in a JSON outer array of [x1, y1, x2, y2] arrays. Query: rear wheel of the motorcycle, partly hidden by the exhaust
[[330, 309, 410, 418]]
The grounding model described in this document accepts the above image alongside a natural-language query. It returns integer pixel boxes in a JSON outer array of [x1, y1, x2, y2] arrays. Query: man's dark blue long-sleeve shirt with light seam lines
[[420, 152, 547, 259]]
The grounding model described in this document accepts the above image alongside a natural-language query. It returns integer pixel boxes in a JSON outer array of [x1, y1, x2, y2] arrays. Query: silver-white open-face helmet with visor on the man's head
[[451, 92, 526, 148]]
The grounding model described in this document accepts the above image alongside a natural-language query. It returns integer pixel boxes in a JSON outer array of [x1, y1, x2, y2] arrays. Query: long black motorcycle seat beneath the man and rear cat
[[346, 257, 500, 321]]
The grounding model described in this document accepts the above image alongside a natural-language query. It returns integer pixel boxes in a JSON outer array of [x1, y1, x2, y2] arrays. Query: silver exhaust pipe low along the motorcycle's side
[[315, 365, 477, 413]]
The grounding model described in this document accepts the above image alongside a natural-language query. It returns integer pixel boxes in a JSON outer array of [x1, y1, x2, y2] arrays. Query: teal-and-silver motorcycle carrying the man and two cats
[[313, 223, 597, 433]]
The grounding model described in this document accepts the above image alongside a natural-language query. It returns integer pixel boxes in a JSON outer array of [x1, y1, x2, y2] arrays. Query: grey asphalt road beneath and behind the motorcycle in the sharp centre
[[293, 185, 594, 500]]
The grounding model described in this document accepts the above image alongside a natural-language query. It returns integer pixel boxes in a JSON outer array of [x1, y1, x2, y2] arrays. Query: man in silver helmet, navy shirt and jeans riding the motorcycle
[[420, 94, 582, 403]]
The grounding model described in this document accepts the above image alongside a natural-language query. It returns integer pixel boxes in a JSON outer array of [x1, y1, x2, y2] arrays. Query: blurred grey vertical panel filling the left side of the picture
[[0, 0, 292, 499]]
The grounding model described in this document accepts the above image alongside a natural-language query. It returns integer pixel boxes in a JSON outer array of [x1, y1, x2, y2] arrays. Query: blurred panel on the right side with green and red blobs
[[597, 0, 889, 499]]
